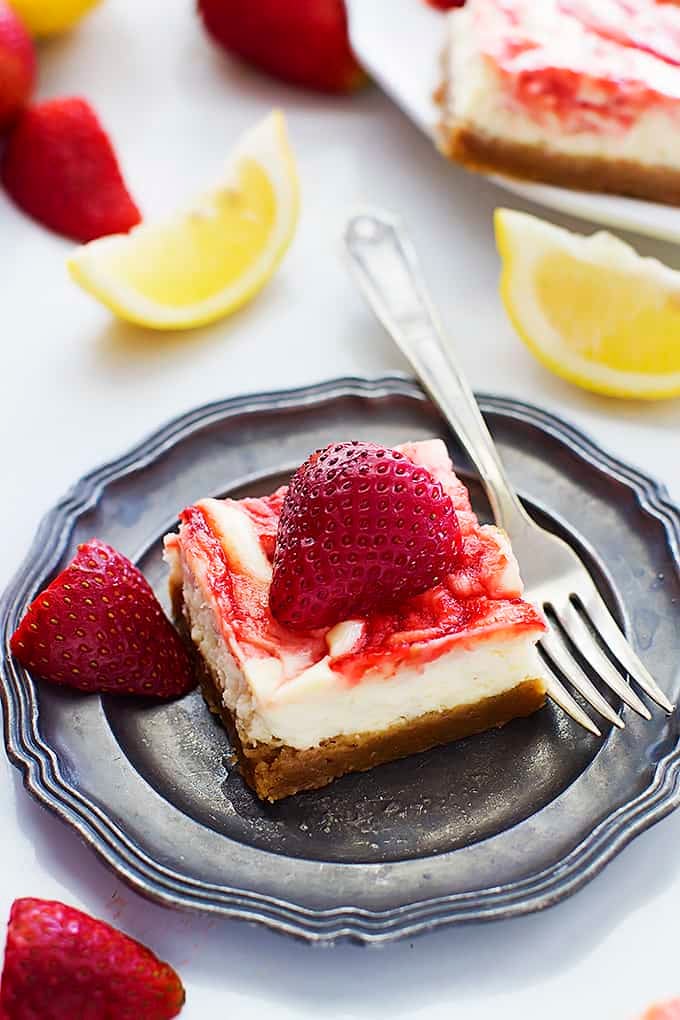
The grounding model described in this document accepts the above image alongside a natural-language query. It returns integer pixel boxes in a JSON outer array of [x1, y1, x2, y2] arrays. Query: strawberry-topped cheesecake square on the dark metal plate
[[165, 440, 545, 801]]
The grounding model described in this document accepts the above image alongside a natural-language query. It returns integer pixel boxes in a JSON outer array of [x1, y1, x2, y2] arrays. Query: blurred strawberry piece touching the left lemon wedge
[[0, 99, 141, 242]]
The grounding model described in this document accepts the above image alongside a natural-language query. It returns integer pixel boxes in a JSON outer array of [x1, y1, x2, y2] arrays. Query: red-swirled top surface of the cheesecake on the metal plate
[[165, 441, 542, 682]]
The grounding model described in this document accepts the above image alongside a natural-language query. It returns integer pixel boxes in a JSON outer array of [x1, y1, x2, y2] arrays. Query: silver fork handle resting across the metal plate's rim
[[345, 211, 529, 539]]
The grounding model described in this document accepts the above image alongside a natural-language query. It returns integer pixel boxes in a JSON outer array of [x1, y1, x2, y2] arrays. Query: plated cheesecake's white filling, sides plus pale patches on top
[[165, 440, 542, 749]]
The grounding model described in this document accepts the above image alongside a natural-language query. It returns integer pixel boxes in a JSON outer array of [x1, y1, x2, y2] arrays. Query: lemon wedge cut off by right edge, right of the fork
[[495, 209, 680, 400]]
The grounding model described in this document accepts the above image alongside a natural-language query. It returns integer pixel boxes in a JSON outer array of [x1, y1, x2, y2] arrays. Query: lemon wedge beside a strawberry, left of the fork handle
[[68, 111, 299, 329]]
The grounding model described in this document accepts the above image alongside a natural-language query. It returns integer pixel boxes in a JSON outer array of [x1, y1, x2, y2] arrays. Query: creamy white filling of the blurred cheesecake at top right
[[446, 0, 680, 168]]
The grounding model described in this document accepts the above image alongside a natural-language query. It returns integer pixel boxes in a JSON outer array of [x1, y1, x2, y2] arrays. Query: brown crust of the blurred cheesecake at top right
[[438, 124, 680, 205]]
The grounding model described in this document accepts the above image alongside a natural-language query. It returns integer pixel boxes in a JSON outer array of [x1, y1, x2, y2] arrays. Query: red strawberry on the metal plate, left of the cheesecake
[[10, 539, 195, 698]]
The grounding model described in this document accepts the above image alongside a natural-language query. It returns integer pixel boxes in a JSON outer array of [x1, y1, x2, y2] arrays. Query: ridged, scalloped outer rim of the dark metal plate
[[0, 374, 680, 944]]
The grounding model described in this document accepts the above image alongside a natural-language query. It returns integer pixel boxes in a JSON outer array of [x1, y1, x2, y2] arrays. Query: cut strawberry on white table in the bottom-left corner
[[0, 899, 185, 1020]]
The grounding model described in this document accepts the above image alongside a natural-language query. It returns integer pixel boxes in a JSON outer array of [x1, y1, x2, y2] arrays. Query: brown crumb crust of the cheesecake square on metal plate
[[171, 589, 545, 803]]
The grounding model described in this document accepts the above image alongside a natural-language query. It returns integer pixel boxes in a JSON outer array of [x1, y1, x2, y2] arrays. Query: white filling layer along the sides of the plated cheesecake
[[178, 558, 541, 749]]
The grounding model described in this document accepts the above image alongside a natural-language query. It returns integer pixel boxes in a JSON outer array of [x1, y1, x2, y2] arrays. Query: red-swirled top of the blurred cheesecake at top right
[[477, 0, 680, 132]]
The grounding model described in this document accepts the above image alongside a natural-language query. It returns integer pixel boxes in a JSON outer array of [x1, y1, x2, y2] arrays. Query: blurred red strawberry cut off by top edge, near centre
[[199, 0, 365, 92]]
